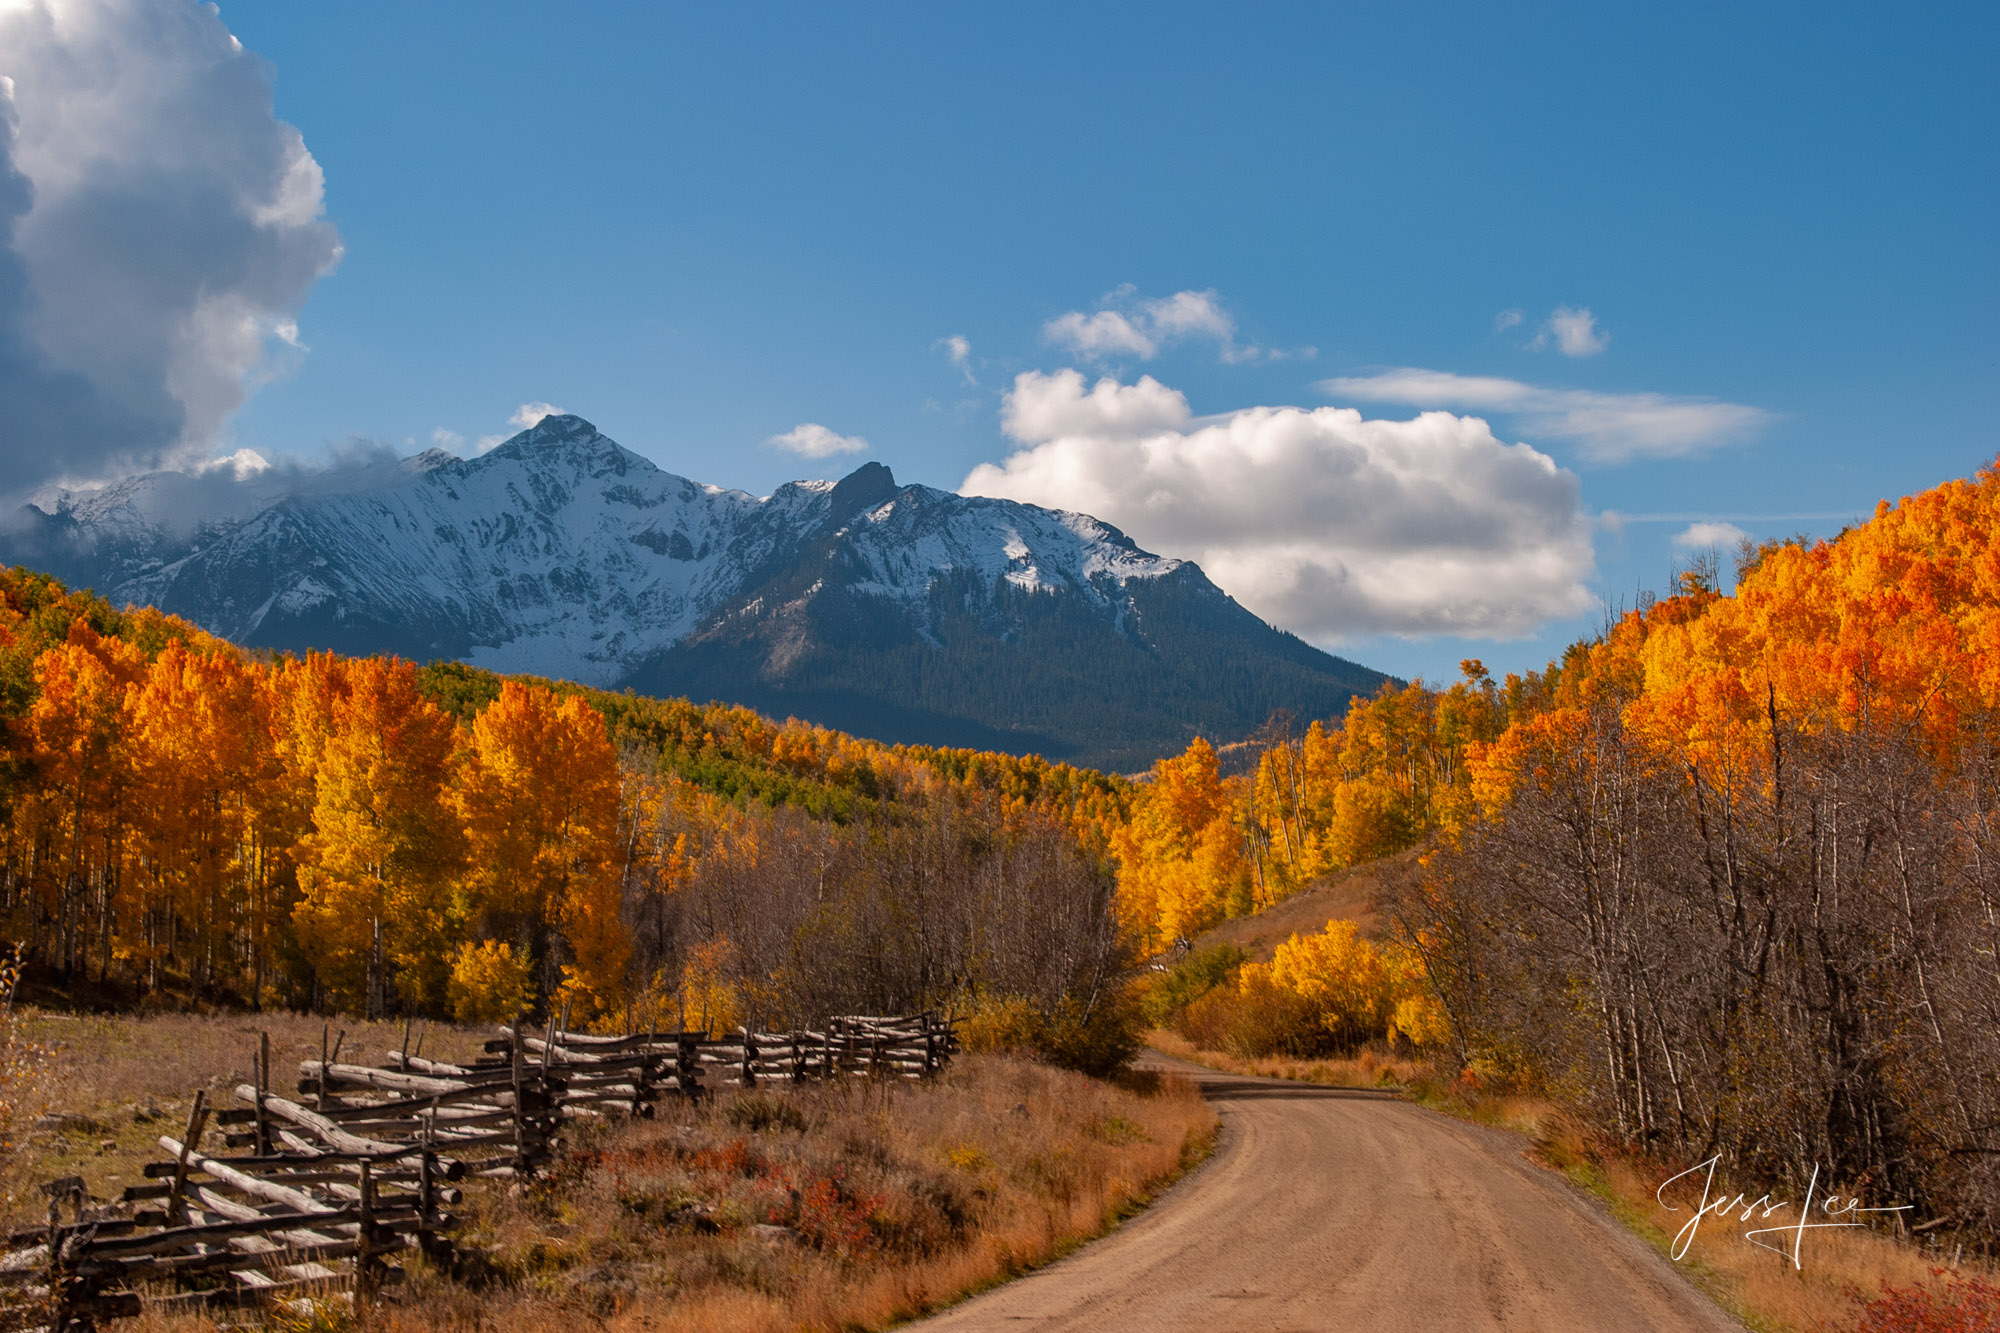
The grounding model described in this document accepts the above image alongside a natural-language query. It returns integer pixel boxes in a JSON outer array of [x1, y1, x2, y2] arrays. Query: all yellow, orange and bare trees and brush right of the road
[[1114, 456, 2000, 1329]]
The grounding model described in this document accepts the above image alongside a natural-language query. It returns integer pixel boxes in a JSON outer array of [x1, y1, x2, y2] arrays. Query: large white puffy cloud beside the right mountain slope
[[960, 370, 1594, 642]]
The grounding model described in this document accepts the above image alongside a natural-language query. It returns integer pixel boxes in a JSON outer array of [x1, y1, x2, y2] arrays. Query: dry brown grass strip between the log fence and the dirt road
[[360, 1055, 1216, 1333]]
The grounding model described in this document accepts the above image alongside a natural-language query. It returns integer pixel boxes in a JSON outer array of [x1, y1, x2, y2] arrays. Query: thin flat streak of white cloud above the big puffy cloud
[[1318, 368, 1772, 462]]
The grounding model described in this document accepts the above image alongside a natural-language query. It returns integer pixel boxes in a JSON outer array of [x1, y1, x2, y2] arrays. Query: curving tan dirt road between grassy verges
[[916, 1061, 1742, 1333]]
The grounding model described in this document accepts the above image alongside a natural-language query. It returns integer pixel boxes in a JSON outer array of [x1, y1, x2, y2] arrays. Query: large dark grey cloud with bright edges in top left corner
[[0, 0, 340, 490]]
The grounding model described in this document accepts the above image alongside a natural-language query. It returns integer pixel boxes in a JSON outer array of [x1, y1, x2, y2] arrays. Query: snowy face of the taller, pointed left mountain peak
[[105, 416, 832, 685]]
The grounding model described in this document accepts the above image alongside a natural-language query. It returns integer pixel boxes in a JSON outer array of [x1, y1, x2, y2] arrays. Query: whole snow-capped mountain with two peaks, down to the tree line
[[0, 416, 1382, 767]]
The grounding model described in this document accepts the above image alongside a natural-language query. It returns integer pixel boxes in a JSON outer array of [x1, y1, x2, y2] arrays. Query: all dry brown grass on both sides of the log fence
[[20, 1015, 1216, 1333]]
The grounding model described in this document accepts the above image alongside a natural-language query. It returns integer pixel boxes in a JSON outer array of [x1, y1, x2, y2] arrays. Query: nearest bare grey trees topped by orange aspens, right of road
[[1398, 468, 2000, 1240]]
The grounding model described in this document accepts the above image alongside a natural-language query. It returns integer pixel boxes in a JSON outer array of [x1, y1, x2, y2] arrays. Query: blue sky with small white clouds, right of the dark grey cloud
[[0, 0, 2000, 677]]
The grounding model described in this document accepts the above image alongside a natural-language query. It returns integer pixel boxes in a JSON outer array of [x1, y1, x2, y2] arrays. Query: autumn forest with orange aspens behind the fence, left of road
[[0, 570, 1128, 1056]]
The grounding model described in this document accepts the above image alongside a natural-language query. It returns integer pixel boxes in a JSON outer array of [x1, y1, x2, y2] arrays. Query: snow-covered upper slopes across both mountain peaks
[[15, 416, 1180, 685]]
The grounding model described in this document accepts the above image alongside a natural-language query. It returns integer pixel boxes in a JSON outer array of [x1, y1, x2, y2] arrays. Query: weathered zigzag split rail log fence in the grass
[[0, 1013, 956, 1333]]
